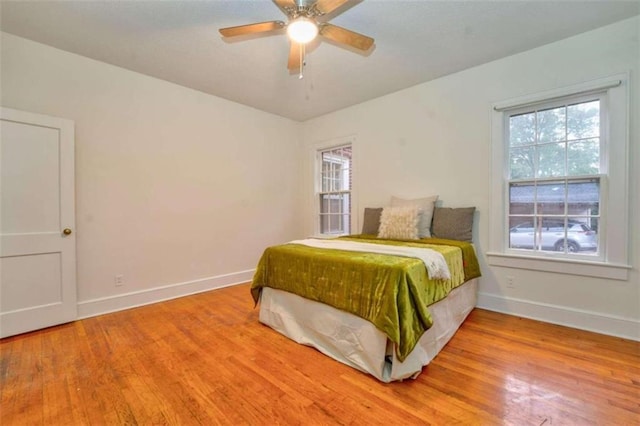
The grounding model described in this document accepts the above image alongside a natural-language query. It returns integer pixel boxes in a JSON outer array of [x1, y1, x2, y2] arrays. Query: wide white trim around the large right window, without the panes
[[487, 73, 631, 280]]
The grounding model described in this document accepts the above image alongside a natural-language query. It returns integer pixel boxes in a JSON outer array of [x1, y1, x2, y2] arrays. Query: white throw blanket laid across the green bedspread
[[289, 238, 451, 280]]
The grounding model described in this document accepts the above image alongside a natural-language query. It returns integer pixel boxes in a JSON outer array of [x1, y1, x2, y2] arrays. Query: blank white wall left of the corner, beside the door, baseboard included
[[1, 33, 301, 316]]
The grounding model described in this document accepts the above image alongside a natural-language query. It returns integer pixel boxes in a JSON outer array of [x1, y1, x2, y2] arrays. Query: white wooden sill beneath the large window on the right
[[487, 252, 631, 281]]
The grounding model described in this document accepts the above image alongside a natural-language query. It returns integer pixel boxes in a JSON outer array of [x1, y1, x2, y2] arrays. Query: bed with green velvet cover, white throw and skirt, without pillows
[[251, 234, 480, 382]]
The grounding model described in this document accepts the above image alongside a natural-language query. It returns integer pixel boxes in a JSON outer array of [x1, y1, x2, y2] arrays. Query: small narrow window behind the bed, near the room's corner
[[316, 144, 352, 235]]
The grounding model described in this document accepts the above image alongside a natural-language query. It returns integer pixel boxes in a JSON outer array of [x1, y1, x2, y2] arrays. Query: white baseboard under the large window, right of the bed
[[477, 293, 640, 341]]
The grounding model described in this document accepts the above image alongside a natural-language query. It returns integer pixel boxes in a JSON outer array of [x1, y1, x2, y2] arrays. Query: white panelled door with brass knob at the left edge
[[0, 108, 77, 337]]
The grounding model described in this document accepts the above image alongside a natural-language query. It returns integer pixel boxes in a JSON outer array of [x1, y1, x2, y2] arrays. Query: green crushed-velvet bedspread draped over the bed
[[251, 236, 478, 361]]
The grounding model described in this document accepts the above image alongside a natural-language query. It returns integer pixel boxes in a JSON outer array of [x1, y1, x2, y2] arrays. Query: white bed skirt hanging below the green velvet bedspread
[[260, 278, 478, 382]]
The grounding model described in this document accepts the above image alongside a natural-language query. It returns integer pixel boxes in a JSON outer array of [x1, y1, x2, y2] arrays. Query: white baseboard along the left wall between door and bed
[[78, 269, 255, 319]]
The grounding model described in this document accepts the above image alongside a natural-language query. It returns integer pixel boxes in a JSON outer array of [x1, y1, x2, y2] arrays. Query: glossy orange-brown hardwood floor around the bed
[[0, 285, 640, 426]]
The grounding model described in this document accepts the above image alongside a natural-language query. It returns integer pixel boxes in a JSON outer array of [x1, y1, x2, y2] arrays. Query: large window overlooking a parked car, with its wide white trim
[[487, 74, 630, 279]]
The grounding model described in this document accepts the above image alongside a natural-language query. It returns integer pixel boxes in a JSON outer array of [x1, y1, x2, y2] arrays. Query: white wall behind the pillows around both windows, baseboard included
[[302, 18, 640, 339]]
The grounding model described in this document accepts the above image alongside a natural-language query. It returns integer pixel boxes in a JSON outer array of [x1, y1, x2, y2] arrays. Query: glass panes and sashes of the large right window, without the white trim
[[504, 94, 606, 257]]
